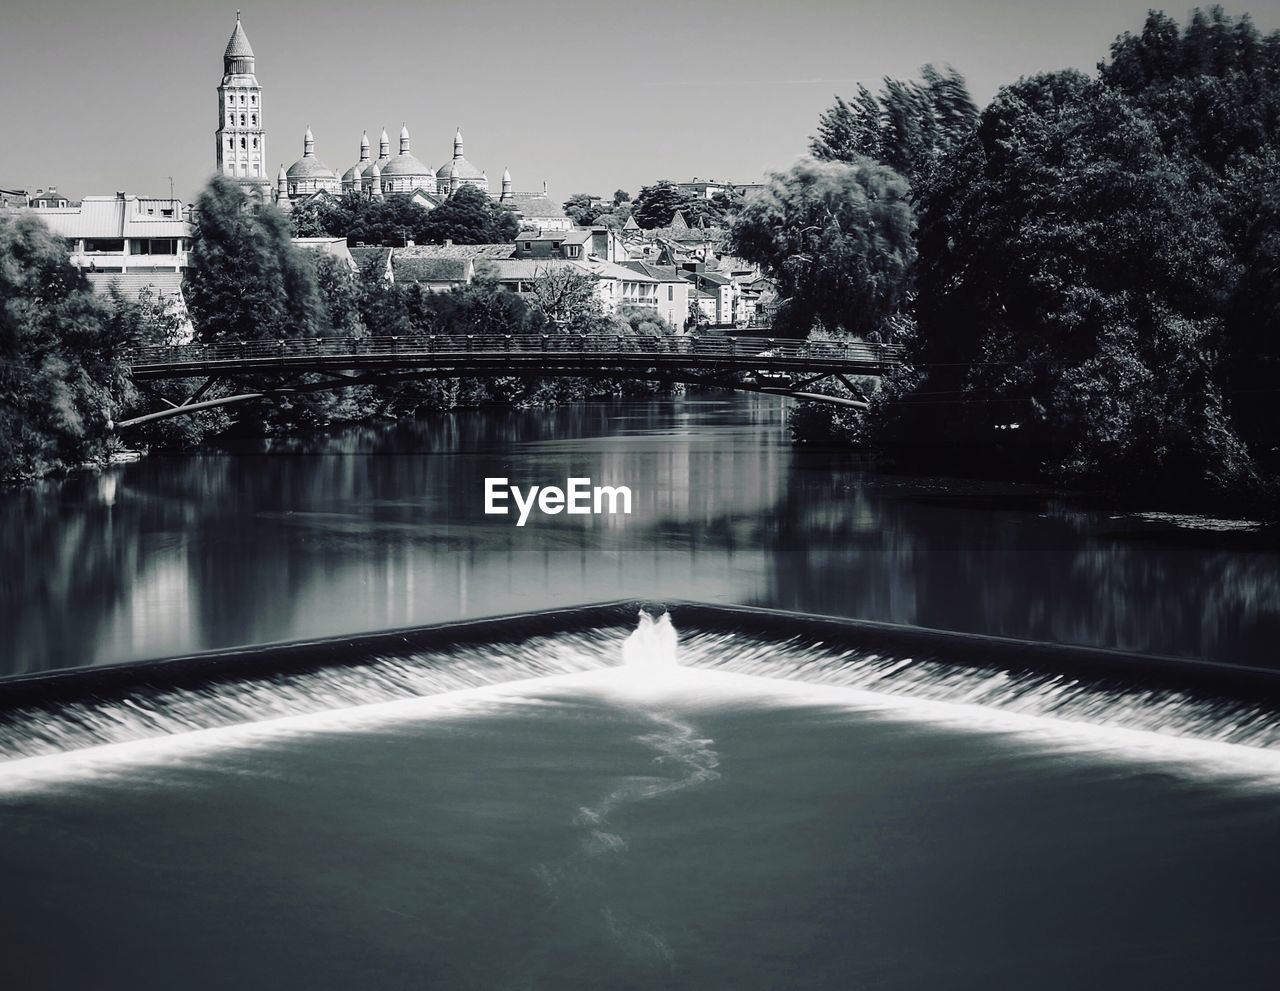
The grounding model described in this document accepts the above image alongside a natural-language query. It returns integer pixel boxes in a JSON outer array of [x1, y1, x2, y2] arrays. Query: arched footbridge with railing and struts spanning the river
[[115, 334, 902, 428]]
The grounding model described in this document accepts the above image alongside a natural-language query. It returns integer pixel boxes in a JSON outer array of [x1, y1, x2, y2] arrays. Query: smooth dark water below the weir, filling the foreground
[[0, 670, 1280, 991]]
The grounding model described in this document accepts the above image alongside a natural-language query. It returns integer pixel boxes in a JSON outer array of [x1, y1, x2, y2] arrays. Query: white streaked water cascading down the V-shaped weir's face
[[0, 609, 1280, 766]]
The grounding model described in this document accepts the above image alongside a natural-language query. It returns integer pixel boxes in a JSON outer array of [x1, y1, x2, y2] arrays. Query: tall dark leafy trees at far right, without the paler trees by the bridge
[[900, 9, 1280, 493]]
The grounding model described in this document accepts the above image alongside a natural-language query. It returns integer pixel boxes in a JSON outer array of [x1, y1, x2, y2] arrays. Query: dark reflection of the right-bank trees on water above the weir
[[759, 469, 1280, 665]]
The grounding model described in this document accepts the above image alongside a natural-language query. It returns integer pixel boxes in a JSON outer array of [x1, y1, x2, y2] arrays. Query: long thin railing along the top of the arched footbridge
[[129, 333, 902, 365]]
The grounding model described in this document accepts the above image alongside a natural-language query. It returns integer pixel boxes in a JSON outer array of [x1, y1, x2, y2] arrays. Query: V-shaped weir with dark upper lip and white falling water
[[0, 602, 1280, 767]]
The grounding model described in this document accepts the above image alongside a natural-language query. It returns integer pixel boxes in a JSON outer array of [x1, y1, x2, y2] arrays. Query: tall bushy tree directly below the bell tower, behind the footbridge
[[184, 175, 320, 341]]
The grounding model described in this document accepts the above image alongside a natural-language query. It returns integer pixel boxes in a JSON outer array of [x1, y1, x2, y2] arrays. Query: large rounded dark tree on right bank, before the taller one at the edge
[[916, 65, 1252, 492]]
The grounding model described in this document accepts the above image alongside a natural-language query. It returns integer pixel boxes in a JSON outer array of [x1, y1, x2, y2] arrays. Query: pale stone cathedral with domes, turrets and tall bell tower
[[216, 10, 570, 229]]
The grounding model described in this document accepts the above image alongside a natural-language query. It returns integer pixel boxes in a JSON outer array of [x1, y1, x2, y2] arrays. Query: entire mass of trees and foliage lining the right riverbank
[[747, 8, 1280, 511]]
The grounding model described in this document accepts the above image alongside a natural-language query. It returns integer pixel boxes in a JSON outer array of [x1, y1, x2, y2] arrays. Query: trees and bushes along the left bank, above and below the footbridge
[[0, 178, 675, 480]]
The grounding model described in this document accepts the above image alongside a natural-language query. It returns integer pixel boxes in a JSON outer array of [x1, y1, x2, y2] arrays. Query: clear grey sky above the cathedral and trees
[[0, 0, 1280, 200]]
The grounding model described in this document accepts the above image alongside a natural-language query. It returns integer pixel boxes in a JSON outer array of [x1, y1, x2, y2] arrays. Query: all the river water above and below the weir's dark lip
[[0, 396, 1280, 991]]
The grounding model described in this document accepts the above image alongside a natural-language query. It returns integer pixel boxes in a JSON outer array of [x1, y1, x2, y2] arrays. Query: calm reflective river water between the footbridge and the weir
[[0, 396, 1280, 673]]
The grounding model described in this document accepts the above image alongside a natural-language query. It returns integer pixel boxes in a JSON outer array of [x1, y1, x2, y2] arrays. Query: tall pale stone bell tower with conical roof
[[216, 10, 271, 202]]
